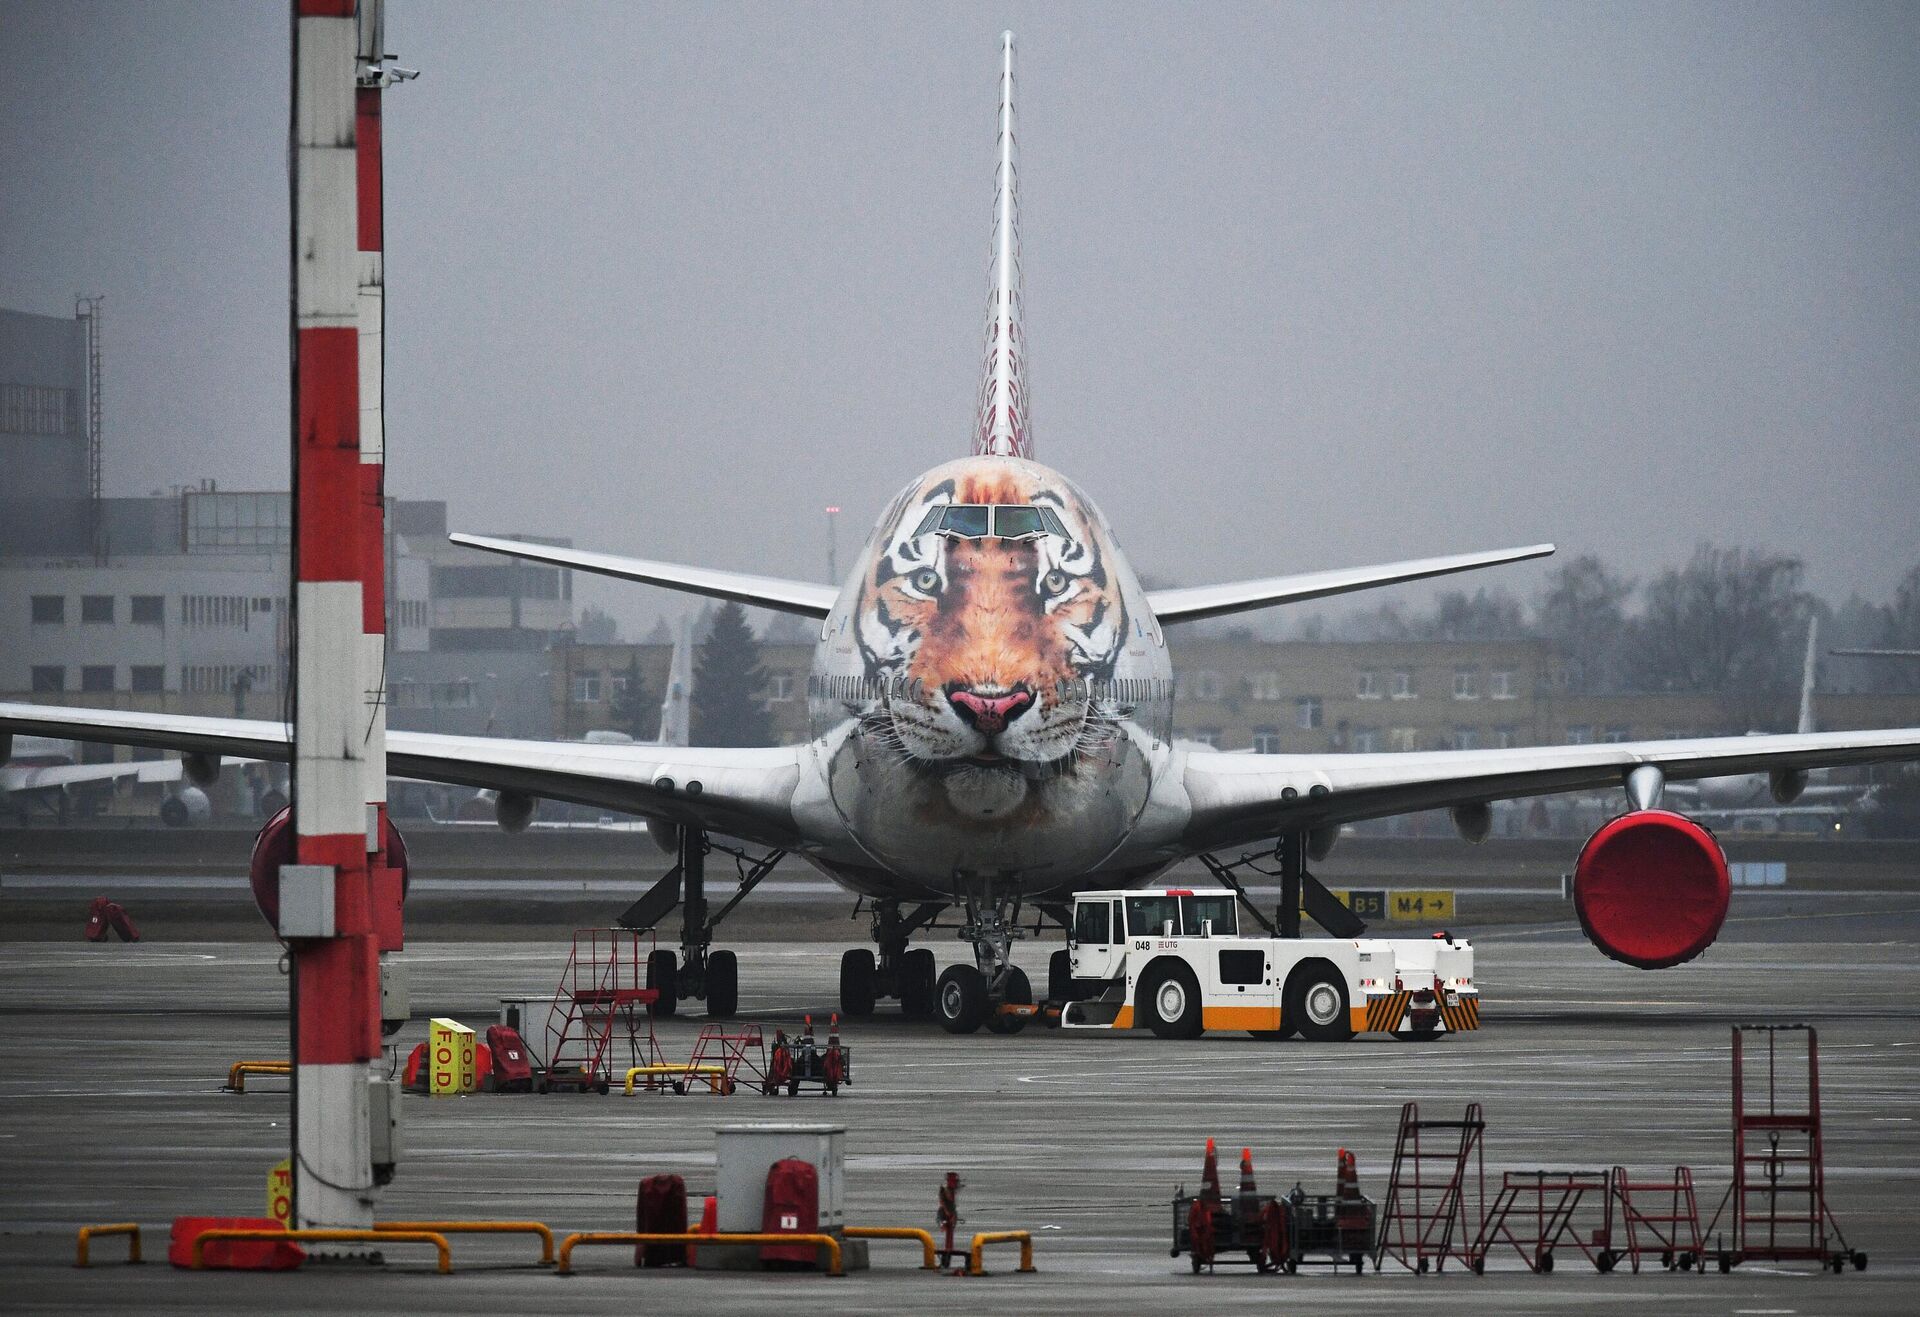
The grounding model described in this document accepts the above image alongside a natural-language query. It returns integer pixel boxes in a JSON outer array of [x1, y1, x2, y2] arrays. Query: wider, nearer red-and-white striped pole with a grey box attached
[[280, 0, 380, 1229]]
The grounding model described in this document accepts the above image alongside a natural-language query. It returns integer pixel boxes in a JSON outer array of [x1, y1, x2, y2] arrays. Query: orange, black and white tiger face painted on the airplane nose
[[837, 457, 1127, 814]]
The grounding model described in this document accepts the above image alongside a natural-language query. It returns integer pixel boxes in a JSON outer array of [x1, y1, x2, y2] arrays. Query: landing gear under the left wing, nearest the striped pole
[[620, 827, 785, 1019]]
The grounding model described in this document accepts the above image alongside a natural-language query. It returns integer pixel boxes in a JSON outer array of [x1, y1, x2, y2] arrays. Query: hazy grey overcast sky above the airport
[[0, 0, 1920, 641]]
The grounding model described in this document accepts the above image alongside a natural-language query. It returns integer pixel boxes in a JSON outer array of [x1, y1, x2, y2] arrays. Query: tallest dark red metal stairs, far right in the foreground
[[1707, 1025, 1866, 1273]]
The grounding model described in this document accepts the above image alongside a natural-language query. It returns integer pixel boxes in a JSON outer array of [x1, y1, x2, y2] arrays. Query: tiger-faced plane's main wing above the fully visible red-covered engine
[[1183, 728, 1920, 850]]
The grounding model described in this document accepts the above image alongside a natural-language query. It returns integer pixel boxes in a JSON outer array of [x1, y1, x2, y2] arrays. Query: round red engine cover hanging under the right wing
[[1572, 810, 1732, 970]]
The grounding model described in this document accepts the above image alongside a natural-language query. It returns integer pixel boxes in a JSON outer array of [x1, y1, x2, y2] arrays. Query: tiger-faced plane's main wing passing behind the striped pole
[[0, 703, 804, 849]]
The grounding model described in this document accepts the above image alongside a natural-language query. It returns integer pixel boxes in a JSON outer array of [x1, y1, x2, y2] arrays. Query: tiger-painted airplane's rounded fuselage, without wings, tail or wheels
[[787, 457, 1173, 897]]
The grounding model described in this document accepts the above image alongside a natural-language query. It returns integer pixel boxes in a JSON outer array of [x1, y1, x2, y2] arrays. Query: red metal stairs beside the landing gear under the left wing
[[536, 929, 660, 1092]]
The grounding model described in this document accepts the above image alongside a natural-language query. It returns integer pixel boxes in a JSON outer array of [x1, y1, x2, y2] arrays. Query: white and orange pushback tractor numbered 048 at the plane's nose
[[1060, 887, 1480, 1042]]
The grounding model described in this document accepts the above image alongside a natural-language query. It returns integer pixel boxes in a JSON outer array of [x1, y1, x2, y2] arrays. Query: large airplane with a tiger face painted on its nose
[[0, 33, 1920, 1033]]
